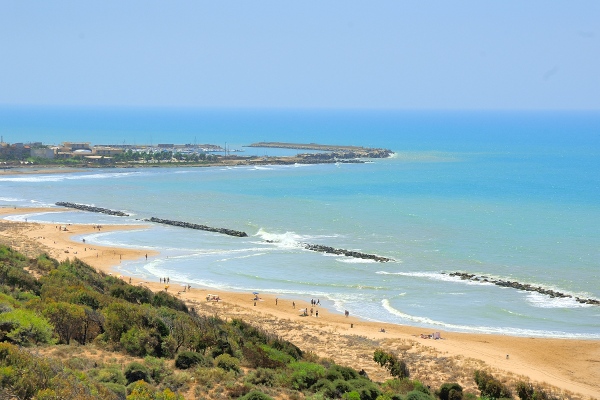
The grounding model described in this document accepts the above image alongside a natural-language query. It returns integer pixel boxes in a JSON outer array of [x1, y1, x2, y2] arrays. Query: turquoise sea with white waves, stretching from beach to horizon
[[0, 108, 600, 339]]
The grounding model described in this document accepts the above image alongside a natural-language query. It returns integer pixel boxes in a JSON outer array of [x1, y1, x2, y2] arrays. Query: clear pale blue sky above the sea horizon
[[0, 0, 600, 110]]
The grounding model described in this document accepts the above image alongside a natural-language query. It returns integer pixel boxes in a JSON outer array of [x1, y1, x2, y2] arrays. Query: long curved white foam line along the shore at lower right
[[381, 299, 600, 339]]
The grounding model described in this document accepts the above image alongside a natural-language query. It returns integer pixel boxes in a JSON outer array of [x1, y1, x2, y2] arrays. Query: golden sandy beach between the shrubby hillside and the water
[[0, 208, 600, 398]]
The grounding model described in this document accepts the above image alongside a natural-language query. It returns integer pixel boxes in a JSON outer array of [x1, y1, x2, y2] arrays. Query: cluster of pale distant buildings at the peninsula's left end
[[0, 141, 123, 160]]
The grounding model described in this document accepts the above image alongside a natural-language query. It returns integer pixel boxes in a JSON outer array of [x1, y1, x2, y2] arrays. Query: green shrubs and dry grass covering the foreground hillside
[[0, 246, 568, 400]]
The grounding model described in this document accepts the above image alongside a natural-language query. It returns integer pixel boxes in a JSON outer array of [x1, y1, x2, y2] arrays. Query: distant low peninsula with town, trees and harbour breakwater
[[0, 140, 393, 168]]
